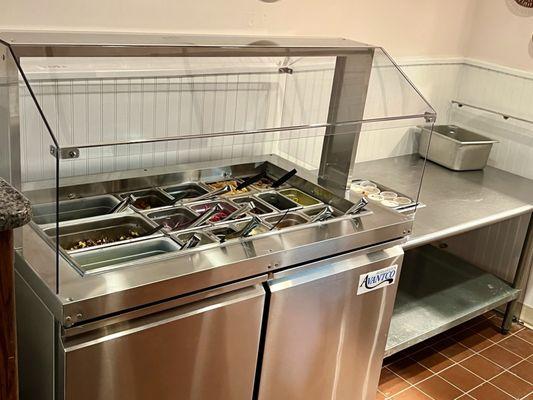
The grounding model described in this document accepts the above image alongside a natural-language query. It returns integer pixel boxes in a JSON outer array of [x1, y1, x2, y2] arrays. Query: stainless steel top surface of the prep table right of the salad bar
[[356, 155, 533, 248]]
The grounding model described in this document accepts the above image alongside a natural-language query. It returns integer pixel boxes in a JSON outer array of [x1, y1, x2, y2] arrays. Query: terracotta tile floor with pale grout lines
[[376, 312, 533, 400]]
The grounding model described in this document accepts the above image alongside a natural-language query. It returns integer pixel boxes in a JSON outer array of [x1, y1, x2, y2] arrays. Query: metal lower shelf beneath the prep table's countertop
[[385, 245, 519, 356]]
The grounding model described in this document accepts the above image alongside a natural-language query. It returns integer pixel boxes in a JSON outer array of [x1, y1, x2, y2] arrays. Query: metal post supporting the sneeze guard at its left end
[[0, 43, 21, 189]]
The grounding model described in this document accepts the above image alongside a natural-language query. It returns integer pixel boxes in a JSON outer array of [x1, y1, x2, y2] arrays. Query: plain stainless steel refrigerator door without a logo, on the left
[[61, 285, 265, 400]]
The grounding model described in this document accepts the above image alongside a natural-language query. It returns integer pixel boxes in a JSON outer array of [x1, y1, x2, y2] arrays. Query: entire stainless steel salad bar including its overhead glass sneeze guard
[[0, 32, 435, 400]]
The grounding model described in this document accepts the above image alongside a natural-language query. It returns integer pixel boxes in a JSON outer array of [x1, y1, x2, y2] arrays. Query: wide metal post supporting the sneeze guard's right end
[[319, 49, 374, 193]]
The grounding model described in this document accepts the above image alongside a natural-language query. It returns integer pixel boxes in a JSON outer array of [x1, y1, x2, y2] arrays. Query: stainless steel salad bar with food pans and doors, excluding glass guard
[[17, 160, 411, 400]]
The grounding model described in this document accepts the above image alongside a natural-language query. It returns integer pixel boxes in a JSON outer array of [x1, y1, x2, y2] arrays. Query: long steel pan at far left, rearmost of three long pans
[[32, 195, 119, 225]]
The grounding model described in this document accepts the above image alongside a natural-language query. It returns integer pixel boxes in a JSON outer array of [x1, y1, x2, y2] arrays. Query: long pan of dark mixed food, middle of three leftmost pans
[[44, 213, 157, 250]]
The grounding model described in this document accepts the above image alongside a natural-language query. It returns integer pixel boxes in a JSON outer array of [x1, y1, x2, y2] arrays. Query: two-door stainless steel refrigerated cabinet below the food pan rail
[[17, 246, 403, 400]]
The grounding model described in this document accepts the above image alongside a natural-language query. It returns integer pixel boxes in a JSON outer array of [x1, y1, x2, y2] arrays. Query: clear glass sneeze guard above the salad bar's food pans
[[3, 32, 434, 291]]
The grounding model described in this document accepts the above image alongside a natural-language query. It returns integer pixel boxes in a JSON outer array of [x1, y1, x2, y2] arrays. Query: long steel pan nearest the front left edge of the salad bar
[[71, 237, 180, 274]]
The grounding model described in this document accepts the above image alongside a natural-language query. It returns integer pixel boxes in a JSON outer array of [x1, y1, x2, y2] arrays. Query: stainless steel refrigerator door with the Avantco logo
[[259, 246, 403, 400]]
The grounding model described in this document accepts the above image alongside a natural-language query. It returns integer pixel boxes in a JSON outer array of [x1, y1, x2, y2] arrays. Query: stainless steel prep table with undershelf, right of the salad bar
[[358, 155, 533, 355]]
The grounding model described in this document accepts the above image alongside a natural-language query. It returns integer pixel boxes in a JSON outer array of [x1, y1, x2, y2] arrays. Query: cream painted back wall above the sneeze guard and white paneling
[[0, 0, 475, 56]]
